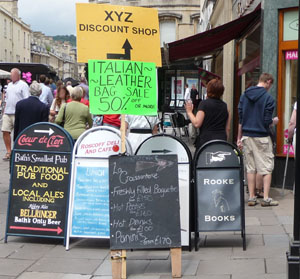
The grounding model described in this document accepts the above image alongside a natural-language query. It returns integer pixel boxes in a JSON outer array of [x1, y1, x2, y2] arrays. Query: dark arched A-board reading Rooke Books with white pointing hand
[[195, 141, 246, 252]]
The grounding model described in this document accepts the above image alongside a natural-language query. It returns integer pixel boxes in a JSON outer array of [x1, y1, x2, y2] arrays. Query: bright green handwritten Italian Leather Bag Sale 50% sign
[[89, 60, 157, 115]]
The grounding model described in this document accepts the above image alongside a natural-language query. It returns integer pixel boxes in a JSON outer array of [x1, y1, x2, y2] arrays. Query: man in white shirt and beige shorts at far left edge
[[2, 68, 30, 161]]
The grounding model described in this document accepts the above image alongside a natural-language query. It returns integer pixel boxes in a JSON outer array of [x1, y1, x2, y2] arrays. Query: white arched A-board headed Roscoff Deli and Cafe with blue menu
[[66, 126, 132, 249]]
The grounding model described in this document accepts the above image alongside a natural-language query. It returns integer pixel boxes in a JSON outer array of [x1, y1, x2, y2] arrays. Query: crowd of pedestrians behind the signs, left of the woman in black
[[2, 68, 159, 155]]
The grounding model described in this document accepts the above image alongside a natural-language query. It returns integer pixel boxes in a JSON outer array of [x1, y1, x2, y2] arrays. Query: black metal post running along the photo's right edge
[[288, 0, 300, 279]]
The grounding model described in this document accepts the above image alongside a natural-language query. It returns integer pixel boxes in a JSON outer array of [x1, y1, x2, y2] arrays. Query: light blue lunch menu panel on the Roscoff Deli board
[[72, 166, 109, 237]]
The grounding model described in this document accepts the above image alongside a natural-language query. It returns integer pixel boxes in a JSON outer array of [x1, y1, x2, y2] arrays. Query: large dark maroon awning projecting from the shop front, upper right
[[168, 6, 261, 62]]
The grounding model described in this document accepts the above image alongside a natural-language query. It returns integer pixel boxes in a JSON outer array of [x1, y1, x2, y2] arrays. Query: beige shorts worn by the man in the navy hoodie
[[242, 137, 274, 175]]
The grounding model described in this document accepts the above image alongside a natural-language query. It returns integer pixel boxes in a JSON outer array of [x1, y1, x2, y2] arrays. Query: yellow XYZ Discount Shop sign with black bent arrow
[[76, 4, 161, 67]]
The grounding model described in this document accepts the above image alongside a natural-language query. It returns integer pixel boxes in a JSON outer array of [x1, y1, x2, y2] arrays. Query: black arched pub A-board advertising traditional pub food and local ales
[[5, 123, 73, 241]]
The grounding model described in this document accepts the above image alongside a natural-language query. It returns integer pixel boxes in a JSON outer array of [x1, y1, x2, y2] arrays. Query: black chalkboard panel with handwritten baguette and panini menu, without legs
[[109, 155, 181, 250]]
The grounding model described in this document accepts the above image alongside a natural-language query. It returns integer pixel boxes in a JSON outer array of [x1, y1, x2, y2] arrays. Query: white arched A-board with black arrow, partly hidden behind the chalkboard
[[135, 135, 192, 249]]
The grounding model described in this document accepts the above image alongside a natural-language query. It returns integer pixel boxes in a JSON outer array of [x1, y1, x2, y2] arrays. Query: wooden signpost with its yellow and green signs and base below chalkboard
[[76, 4, 168, 279]]
